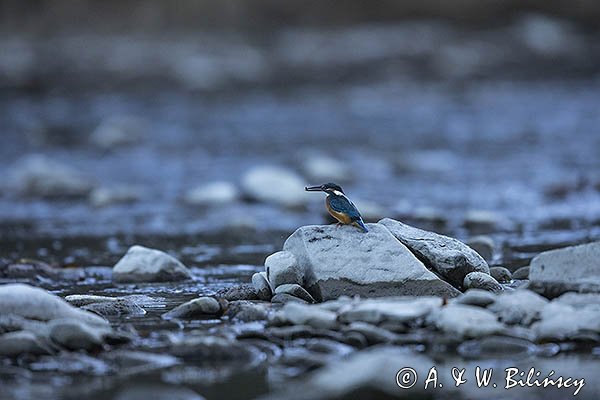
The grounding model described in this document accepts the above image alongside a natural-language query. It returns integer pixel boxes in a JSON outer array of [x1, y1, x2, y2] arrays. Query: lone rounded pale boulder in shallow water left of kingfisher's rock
[[113, 246, 191, 282]]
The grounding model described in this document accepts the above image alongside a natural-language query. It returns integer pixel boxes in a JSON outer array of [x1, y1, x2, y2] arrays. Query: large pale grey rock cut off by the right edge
[[529, 242, 600, 296]]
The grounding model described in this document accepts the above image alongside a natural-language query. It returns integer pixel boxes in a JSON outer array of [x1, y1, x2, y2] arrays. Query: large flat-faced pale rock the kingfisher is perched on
[[283, 224, 459, 301]]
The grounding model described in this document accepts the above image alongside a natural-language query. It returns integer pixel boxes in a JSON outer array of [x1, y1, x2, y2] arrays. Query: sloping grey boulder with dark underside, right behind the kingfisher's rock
[[379, 218, 490, 288]]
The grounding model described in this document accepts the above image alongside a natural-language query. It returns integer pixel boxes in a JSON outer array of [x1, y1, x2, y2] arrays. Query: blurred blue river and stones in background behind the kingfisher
[[0, 0, 600, 265]]
